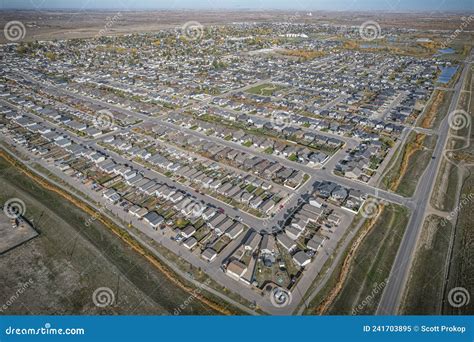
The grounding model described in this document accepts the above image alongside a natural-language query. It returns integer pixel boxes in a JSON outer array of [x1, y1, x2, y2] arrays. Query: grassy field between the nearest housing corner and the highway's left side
[[305, 205, 408, 314]]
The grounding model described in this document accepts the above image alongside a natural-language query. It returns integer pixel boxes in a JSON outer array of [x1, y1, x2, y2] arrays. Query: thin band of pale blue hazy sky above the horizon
[[0, 0, 474, 12]]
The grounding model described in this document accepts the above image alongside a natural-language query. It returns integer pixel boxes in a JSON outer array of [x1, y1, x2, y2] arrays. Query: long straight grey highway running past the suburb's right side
[[377, 51, 472, 315]]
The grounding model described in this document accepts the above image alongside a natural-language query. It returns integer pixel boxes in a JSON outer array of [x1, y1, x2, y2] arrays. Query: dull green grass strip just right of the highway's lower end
[[400, 215, 453, 315]]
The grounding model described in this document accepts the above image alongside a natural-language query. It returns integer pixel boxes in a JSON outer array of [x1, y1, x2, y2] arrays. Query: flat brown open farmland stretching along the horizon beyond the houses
[[0, 10, 470, 43]]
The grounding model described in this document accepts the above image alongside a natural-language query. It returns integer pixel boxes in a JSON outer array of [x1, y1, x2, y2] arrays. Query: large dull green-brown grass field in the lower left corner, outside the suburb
[[0, 159, 220, 314]]
